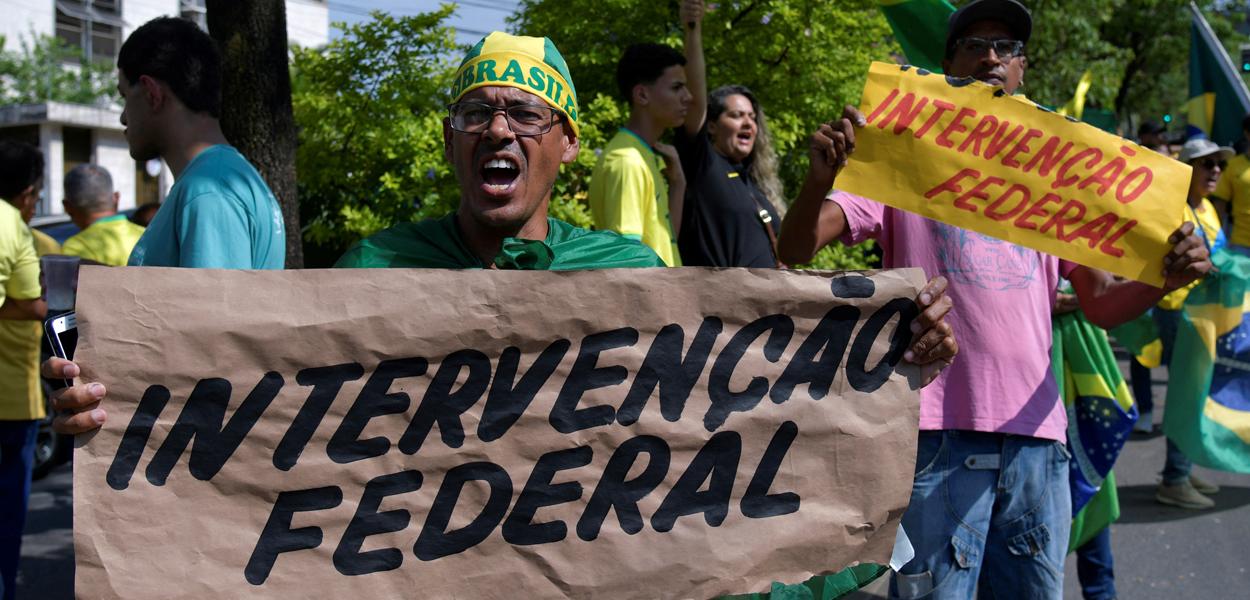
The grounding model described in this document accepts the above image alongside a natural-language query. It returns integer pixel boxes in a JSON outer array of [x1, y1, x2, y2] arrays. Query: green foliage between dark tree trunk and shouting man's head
[[291, 6, 460, 260]]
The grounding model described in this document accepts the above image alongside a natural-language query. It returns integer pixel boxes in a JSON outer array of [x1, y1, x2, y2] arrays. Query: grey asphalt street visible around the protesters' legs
[[18, 361, 1250, 600]]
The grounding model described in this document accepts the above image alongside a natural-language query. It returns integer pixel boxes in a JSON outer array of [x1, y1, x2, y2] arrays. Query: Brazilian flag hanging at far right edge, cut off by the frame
[[1164, 250, 1250, 473]]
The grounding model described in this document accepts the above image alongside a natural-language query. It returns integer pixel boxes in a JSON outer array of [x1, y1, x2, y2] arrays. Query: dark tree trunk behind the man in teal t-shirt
[[206, 0, 304, 269]]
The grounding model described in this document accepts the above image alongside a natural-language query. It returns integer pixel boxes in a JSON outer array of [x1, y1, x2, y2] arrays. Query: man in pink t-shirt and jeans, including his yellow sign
[[779, 0, 1211, 598]]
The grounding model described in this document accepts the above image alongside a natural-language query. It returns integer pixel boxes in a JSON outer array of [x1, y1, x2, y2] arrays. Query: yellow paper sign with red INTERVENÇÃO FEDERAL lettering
[[836, 63, 1190, 286]]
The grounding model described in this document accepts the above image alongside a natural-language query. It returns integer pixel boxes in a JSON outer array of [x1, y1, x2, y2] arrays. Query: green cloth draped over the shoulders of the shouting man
[[334, 214, 664, 271]]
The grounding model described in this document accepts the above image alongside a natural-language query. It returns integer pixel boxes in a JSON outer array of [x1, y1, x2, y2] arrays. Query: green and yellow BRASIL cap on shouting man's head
[[451, 31, 581, 135]]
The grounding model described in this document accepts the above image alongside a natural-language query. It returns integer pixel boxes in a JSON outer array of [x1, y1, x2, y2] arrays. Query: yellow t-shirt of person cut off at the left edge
[[0, 200, 49, 421]]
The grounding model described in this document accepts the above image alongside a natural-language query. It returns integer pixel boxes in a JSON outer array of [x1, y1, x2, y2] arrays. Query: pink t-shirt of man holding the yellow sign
[[829, 191, 1075, 441]]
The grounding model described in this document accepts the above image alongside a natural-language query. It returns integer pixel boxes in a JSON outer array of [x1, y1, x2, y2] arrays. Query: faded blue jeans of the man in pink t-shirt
[[890, 430, 1073, 600]]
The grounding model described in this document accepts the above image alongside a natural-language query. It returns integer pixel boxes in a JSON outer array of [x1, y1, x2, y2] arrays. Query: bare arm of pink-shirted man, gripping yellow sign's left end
[[778, 106, 864, 265]]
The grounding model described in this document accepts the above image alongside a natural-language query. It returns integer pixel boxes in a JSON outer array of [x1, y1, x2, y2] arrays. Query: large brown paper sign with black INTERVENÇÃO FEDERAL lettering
[[74, 268, 924, 599]]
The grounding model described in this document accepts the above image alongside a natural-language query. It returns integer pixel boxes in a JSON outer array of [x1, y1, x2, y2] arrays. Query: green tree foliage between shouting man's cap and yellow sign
[[511, 0, 899, 269]]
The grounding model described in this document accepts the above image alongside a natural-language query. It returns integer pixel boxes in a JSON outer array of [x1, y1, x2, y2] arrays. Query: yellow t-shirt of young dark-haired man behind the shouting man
[[590, 128, 681, 266]]
